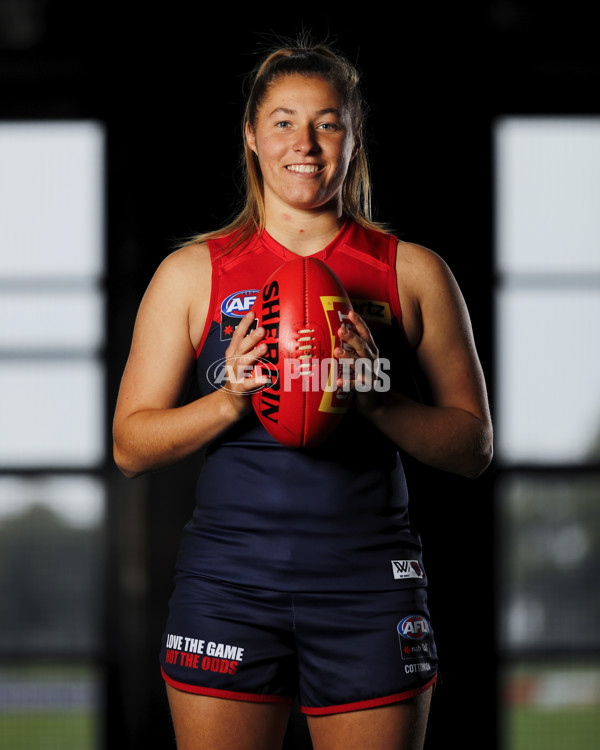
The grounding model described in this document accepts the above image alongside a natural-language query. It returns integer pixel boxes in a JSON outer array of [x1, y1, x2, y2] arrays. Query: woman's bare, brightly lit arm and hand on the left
[[113, 246, 264, 477]]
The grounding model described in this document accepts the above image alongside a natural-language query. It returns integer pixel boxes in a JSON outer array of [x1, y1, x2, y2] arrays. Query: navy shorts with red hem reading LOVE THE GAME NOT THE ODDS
[[160, 574, 437, 715]]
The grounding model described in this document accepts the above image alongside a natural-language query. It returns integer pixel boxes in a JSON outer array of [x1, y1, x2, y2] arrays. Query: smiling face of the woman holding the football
[[246, 75, 358, 215]]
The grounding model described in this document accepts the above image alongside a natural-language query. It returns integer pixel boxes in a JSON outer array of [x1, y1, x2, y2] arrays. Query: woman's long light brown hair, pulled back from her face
[[191, 42, 385, 251]]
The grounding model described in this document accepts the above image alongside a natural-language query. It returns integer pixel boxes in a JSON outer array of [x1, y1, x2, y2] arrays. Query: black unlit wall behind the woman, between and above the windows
[[0, 0, 600, 749]]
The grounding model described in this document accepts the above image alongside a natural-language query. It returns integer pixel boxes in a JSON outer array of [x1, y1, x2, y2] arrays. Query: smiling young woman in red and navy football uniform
[[114, 46, 492, 750]]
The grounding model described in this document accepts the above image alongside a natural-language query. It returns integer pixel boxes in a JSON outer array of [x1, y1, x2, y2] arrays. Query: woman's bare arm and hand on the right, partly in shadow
[[341, 243, 492, 477]]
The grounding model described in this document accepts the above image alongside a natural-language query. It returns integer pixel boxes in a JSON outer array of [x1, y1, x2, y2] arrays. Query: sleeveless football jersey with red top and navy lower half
[[178, 221, 426, 591]]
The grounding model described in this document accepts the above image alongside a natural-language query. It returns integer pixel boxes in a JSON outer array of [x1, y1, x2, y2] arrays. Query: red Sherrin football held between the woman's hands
[[252, 257, 352, 448]]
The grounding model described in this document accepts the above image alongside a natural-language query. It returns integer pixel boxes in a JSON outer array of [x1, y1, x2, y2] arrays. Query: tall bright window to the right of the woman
[[494, 117, 600, 750]]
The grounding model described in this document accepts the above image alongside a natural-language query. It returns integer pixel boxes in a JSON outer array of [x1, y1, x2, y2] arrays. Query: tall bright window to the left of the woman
[[0, 122, 105, 750]]
